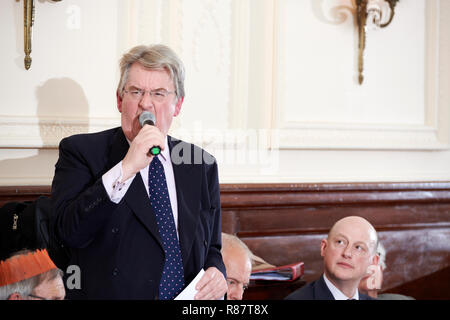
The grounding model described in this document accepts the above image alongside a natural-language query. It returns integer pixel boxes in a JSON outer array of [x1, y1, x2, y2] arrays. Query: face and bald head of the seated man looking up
[[321, 219, 378, 286]]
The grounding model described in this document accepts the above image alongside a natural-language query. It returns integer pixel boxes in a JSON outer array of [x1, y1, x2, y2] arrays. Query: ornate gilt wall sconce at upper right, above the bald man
[[356, 0, 400, 84]]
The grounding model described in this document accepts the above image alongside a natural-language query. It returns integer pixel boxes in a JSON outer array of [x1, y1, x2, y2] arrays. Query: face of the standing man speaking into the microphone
[[117, 63, 183, 141]]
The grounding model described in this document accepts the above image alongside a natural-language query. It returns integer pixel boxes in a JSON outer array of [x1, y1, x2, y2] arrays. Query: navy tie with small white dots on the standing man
[[148, 157, 184, 300]]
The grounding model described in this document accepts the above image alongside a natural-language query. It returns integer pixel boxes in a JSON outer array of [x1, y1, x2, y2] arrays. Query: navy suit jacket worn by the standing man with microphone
[[52, 127, 225, 299]]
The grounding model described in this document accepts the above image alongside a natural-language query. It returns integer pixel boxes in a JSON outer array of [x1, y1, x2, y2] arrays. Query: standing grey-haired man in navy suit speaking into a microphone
[[52, 45, 227, 300]]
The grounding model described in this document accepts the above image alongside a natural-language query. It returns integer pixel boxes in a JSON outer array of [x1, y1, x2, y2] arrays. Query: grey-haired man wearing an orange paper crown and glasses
[[0, 249, 66, 300]]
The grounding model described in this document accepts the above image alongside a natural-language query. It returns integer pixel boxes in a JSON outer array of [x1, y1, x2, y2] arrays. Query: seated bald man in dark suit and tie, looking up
[[285, 217, 378, 300]]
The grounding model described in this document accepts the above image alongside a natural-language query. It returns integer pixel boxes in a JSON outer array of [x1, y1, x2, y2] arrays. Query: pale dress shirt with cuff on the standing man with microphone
[[102, 137, 178, 233]]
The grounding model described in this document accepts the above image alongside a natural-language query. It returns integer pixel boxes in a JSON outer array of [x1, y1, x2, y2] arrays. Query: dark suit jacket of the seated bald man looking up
[[285, 275, 375, 300]]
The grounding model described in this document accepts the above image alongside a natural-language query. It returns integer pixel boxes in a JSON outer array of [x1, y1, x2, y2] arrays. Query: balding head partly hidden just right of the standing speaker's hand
[[223, 247, 252, 300]]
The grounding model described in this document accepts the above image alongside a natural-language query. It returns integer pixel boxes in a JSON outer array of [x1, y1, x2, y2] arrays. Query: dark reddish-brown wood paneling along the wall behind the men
[[0, 182, 450, 299]]
